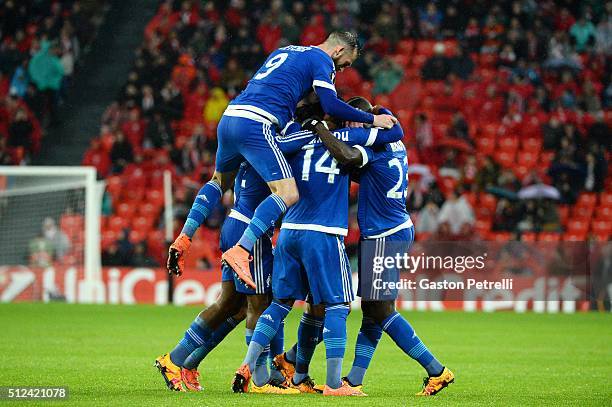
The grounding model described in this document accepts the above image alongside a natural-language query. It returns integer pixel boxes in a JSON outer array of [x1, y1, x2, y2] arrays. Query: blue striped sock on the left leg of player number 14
[[242, 300, 291, 372]]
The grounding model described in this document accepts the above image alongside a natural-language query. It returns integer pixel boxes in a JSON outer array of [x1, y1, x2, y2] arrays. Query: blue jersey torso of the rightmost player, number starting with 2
[[357, 141, 412, 239]]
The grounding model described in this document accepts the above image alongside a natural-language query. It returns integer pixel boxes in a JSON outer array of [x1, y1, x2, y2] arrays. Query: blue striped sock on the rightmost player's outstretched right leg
[[382, 311, 444, 376]]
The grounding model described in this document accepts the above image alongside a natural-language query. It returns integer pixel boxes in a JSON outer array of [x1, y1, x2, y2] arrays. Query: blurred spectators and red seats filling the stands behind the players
[[0, 0, 612, 268]]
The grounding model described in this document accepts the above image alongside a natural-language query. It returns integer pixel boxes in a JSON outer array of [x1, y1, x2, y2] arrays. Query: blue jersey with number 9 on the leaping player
[[230, 45, 336, 129]]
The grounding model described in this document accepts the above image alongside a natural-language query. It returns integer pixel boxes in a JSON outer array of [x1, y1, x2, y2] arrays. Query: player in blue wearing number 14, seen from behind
[[232, 97, 402, 396]]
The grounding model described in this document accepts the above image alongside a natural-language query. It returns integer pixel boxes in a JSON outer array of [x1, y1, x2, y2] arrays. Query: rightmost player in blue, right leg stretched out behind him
[[302, 99, 455, 396]]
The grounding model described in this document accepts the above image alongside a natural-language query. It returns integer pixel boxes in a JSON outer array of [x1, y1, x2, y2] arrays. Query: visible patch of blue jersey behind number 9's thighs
[[232, 161, 270, 223]]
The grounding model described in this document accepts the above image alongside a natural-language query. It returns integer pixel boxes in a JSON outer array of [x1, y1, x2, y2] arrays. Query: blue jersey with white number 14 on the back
[[276, 123, 403, 236]]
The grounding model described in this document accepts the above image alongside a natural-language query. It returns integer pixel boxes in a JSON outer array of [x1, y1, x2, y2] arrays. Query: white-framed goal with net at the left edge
[[0, 166, 102, 301]]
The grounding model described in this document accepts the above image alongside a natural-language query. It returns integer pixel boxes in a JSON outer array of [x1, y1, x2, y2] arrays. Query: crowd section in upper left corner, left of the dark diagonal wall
[[0, 0, 107, 165]]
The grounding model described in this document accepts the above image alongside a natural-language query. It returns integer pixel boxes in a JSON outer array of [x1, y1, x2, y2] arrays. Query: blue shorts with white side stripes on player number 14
[[272, 229, 355, 304]]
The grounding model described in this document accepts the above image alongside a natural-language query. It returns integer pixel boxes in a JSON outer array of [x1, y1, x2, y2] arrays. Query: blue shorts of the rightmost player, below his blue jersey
[[357, 226, 414, 301]]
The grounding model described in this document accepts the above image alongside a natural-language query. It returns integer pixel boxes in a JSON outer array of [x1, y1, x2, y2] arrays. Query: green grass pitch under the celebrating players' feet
[[0, 304, 612, 407]]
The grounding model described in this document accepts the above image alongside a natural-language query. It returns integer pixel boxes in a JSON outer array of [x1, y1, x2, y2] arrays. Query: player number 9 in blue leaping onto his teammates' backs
[[168, 32, 396, 288]]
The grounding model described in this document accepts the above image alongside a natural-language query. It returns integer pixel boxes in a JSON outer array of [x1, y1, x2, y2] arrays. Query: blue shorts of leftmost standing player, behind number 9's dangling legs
[[219, 217, 274, 294]]
